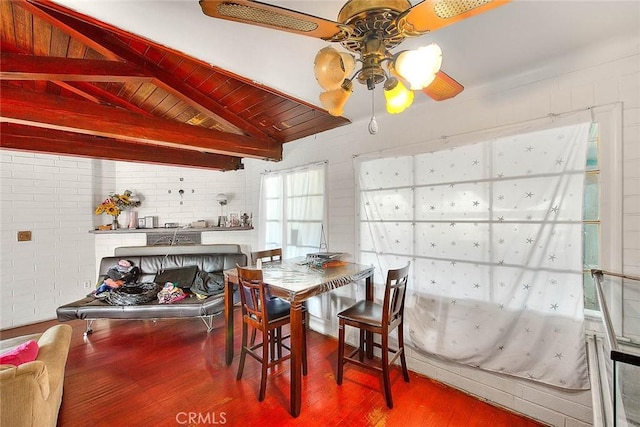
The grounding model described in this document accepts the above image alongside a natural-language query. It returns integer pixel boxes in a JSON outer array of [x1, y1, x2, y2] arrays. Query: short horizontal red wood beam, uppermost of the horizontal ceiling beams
[[0, 53, 154, 83]]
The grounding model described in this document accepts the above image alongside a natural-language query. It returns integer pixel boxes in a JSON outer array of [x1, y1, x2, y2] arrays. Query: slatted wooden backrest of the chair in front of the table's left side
[[236, 265, 267, 329]]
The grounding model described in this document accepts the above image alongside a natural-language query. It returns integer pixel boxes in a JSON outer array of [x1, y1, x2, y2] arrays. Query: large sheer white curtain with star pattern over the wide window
[[357, 123, 591, 389]]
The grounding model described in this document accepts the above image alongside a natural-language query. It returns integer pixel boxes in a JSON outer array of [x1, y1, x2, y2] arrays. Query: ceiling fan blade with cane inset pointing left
[[200, 0, 348, 41]]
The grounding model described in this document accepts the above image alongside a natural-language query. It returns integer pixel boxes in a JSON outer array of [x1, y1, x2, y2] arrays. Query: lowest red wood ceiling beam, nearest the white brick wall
[[0, 122, 242, 171]]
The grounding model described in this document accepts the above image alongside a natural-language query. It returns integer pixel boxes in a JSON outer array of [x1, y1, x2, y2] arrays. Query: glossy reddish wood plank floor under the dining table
[[0, 311, 542, 427]]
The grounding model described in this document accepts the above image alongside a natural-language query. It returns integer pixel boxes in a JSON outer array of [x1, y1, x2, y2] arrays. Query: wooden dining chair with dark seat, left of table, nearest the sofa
[[236, 265, 307, 402]]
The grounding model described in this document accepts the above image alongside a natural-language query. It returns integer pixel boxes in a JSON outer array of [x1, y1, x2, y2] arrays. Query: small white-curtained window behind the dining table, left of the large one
[[260, 162, 327, 258]]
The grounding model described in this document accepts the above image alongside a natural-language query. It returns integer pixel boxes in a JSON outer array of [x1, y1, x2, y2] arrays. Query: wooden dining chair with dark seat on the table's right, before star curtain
[[336, 263, 410, 408]]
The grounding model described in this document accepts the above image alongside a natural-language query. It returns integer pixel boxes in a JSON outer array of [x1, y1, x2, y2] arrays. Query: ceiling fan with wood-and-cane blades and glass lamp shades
[[200, 0, 511, 116]]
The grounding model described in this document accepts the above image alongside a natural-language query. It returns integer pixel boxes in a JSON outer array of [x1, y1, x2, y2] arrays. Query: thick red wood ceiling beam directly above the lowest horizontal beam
[[0, 86, 282, 160]]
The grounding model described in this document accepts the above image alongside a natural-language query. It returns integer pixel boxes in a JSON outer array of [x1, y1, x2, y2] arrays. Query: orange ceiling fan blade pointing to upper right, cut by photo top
[[397, 0, 511, 37]]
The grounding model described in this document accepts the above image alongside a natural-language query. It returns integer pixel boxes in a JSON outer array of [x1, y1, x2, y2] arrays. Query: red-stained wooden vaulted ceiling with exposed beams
[[0, 0, 349, 170]]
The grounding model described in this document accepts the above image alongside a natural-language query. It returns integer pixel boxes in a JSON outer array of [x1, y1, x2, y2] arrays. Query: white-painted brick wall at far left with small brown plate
[[0, 150, 94, 329]]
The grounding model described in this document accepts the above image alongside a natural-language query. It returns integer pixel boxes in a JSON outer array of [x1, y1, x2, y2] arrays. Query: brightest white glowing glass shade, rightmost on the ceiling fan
[[392, 43, 442, 90]]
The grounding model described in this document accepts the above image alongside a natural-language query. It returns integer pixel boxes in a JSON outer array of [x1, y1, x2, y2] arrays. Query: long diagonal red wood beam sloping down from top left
[[29, 0, 279, 145]]
